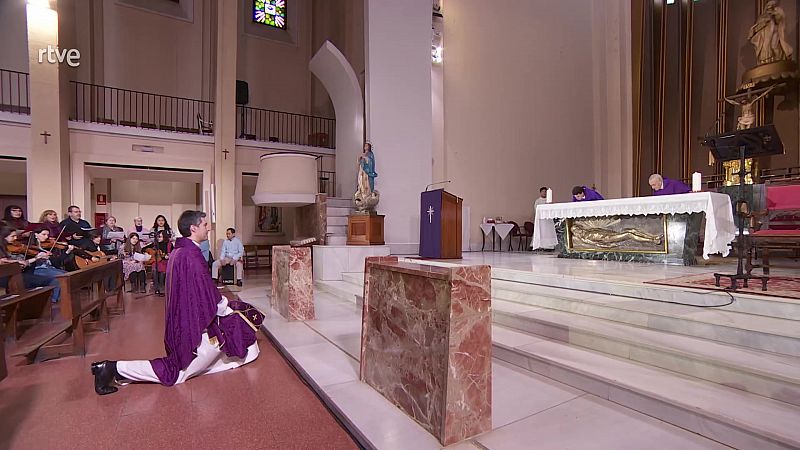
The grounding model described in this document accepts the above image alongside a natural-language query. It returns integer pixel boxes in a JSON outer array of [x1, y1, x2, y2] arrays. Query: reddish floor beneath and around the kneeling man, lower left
[[0, 284, 356, 450]]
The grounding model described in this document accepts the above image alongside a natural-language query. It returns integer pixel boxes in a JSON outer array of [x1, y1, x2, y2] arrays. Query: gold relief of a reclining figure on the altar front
[[567, 215, 669, 254]]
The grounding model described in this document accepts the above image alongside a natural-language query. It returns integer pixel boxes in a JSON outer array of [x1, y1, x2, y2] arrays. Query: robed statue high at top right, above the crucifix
[[747, 0, 792, 64]]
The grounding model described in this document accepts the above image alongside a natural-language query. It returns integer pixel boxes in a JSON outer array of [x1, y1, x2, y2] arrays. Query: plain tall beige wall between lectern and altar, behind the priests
[[444, 0, 620, 248]]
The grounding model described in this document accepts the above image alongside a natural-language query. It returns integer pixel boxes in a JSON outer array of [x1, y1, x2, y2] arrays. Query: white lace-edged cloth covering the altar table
[[531, 192, 736, 259]]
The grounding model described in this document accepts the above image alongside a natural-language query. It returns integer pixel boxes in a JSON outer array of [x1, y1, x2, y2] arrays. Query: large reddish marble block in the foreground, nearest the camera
[[360, 258, 492, 445]]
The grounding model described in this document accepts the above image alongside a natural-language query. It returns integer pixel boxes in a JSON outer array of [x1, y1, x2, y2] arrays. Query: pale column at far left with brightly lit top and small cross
[[27, 0, 72, 217]]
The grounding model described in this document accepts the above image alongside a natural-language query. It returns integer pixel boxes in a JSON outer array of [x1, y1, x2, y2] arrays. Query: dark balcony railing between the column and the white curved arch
[[236, 106, 336, 148]]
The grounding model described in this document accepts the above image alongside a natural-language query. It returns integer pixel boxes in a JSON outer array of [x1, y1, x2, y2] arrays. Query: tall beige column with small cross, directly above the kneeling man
[[211, 2, 241, 243]]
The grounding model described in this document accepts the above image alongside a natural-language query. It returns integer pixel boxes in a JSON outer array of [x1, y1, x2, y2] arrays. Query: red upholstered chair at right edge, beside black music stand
[[746, 182, 800, 276]]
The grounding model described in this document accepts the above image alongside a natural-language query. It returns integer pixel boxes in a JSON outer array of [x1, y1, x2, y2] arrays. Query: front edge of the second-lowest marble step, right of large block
[[492, 309, 800, 406]]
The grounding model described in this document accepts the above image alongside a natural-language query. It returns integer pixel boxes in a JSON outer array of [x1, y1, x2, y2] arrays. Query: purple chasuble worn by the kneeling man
[[150, 237, 256, 386]]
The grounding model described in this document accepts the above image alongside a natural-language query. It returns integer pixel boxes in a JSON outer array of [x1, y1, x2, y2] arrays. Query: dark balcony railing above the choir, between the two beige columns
[[70, 81, 214, 133]]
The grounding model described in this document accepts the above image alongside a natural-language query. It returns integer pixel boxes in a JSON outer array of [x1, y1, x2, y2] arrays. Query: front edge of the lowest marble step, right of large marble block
[[492, 326, 800, 448]]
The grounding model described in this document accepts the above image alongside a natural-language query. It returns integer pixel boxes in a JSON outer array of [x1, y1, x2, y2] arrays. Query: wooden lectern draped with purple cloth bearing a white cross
[[419, 189, 463, 259]]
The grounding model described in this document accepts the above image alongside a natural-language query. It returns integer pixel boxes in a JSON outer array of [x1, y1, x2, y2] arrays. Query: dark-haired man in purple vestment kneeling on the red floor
[[92, 211, 258, 395]]
